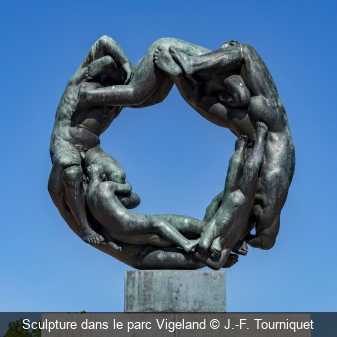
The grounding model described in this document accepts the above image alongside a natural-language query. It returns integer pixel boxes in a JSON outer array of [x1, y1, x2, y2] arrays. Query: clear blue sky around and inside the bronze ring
[[0, 0, 337, 312]]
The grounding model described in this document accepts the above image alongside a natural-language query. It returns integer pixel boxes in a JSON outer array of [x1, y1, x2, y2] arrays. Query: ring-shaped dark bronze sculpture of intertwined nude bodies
[[48, 36, 295, 269]]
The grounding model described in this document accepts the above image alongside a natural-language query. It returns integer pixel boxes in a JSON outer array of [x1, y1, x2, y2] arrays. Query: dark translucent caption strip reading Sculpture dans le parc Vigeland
[[0, 312, 337, 337]]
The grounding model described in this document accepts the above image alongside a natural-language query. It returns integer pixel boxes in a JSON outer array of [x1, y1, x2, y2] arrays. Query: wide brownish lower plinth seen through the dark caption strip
[[40, 313, 314, 337]]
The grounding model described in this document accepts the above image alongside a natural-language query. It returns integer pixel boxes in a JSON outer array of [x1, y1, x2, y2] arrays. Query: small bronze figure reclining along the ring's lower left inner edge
[[86, 164, 205, 253]]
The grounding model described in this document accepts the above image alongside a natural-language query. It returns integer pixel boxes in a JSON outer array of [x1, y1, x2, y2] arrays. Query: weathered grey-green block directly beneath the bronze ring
[[124, 270, 226, 312]]
